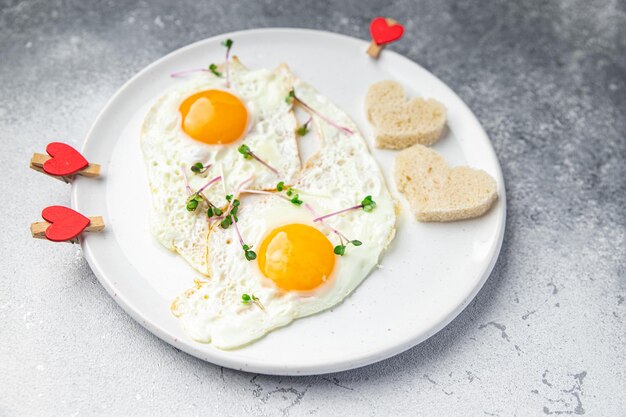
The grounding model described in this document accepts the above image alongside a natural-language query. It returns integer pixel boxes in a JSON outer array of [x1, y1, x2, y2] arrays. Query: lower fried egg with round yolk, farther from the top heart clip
[[167, 64, 396, 349]]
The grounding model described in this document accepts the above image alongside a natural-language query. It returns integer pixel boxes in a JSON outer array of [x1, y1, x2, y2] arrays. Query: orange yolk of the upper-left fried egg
[[178, 90, 248, 145]]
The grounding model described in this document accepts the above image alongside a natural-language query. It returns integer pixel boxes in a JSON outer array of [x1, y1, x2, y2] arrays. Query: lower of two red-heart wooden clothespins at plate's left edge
[[30, 206, 104, 243]]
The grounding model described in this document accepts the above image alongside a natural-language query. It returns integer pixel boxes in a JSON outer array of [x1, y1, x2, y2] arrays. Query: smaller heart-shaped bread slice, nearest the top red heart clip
[[365, 80, 446, 149]]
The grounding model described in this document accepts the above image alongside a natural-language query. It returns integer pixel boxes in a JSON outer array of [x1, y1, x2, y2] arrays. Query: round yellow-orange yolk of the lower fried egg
[[258, 224, 335, 291]]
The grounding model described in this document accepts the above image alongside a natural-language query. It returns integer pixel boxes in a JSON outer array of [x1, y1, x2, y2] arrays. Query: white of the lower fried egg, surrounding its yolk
[[172, 66, 396, 349]]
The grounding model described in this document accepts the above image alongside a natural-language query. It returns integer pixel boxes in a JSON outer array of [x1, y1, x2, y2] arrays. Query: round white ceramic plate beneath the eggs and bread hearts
[[72, 29, 506, 375]]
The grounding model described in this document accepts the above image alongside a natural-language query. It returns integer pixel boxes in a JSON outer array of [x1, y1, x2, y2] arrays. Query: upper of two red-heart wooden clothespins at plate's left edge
[[30, 142, 100, 182]]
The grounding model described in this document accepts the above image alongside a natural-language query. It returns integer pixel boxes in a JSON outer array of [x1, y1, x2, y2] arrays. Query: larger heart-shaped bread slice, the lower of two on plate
[[394, 145, 498, 222]]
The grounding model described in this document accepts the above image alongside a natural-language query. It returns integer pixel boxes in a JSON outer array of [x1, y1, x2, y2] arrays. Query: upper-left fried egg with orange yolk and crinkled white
[[141, 58, 301, 275]]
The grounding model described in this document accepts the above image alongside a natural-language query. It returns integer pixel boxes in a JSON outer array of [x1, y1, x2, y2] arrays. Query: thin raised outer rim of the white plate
[[71, 27, 507, 376]]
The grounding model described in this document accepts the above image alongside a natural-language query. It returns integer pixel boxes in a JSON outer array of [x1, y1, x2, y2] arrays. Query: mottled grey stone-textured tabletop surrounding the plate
[[0, 0, 626, 417]]
